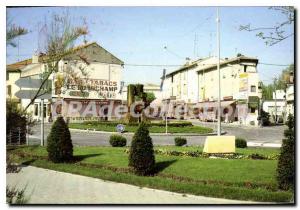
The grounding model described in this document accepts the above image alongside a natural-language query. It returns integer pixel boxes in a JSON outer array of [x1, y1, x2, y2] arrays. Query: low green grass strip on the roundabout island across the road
[[69, 123, 213, 134]]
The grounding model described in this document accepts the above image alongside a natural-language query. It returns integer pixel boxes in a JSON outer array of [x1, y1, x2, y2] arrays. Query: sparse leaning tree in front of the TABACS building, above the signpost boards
[[25, 14, 88, 110]]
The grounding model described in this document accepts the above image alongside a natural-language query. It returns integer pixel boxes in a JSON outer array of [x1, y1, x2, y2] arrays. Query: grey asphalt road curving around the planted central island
[[29, 121, 285, 146]]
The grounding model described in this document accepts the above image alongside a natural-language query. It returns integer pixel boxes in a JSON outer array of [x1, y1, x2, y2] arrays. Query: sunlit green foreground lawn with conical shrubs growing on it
[[8, 146, 293, 202]]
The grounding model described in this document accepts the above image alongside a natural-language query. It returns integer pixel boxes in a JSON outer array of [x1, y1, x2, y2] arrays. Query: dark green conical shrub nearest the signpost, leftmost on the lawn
[[47, 117, 73, 163]]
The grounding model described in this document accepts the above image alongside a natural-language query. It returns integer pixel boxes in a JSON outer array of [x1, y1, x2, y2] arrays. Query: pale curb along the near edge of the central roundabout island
[[69, 128, 226, 136]]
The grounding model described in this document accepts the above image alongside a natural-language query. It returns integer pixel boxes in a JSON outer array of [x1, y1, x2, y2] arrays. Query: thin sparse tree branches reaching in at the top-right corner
[[239, 6, 295, 46]]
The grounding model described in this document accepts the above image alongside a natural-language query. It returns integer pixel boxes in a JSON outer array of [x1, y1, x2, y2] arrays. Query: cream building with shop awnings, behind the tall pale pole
[[163, 55, 261, 125]]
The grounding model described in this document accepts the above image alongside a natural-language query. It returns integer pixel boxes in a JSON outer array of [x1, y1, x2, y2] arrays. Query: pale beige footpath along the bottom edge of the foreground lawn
[[6, 166, 255, 204]]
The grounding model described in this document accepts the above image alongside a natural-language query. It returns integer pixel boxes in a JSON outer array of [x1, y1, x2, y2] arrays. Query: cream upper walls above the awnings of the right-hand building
[[163, 56, 261, 125]]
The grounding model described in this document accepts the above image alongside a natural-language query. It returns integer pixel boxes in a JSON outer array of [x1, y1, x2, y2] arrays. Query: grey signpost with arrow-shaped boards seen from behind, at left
[[15, 77, 51, 146]]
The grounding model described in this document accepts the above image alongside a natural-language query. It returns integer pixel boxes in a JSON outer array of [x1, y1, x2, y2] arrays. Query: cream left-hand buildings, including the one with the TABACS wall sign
[[7, 42, 123, 121]]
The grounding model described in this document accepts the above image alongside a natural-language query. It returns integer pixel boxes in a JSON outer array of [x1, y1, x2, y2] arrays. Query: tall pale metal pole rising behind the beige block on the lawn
[[217, 8, 221, 136]]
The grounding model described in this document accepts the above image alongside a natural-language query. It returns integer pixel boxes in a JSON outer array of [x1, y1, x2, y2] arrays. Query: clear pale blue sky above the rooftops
[[6, 7, 294, 84]]
